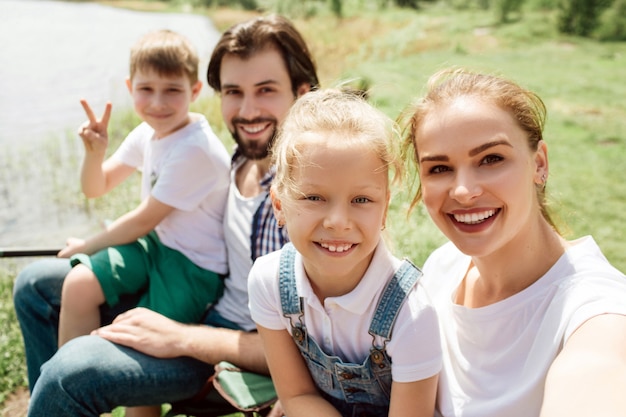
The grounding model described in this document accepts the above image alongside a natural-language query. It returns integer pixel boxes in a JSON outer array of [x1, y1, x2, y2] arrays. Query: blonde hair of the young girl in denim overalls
[[271, 88, 403, 198]]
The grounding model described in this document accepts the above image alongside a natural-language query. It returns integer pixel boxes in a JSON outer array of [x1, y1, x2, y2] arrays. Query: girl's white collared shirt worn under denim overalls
[[248, 241, 441, 382]]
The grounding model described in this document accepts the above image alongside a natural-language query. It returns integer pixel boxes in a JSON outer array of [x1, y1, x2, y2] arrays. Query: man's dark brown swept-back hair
[[207, 14, 319, 95]]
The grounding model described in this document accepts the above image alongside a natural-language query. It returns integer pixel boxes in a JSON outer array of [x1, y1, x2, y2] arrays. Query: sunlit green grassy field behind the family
[[0, 0, 626, 414]]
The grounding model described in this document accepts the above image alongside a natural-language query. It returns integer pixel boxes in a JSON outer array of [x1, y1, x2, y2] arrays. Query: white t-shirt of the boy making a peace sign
[[112, 113, 230, 274]]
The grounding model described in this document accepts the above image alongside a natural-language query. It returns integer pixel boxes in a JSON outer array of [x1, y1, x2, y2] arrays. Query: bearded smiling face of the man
[[220, 48, 296, 160]]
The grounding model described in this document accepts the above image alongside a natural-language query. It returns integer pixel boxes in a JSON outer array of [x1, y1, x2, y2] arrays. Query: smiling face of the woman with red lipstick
[[415, 97, 547, 257]]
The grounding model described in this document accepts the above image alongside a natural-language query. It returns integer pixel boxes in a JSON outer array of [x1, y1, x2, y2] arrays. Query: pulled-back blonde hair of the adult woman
[[399, 68, 557, 230]]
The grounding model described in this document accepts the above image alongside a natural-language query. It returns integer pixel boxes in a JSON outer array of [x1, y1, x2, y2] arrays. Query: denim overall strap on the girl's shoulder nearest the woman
[[369, 259, 422, 340]]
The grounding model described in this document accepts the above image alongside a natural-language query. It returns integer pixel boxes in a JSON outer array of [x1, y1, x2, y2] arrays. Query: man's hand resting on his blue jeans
[[91, 307, 189, 359]]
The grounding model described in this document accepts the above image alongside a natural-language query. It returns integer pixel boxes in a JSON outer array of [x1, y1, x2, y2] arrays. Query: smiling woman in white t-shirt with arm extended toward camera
[[405, 70, 626, 417]]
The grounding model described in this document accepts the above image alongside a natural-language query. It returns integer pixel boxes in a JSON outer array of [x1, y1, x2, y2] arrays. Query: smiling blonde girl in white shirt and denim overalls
[[249, 90, 441, 417]]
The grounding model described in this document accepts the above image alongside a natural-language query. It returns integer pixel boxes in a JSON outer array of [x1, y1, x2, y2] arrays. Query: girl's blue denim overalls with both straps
[[279, 243, 422, 417]]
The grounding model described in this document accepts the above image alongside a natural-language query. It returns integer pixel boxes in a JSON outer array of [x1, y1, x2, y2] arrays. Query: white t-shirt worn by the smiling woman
[[423, 237, 626, 417]]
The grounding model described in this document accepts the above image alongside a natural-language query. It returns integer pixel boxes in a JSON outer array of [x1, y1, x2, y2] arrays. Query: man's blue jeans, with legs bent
[[13, 259, 228, 417]]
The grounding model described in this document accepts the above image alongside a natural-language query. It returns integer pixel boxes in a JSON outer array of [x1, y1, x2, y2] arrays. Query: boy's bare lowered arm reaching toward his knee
[[58, 196, 174, 258]]
